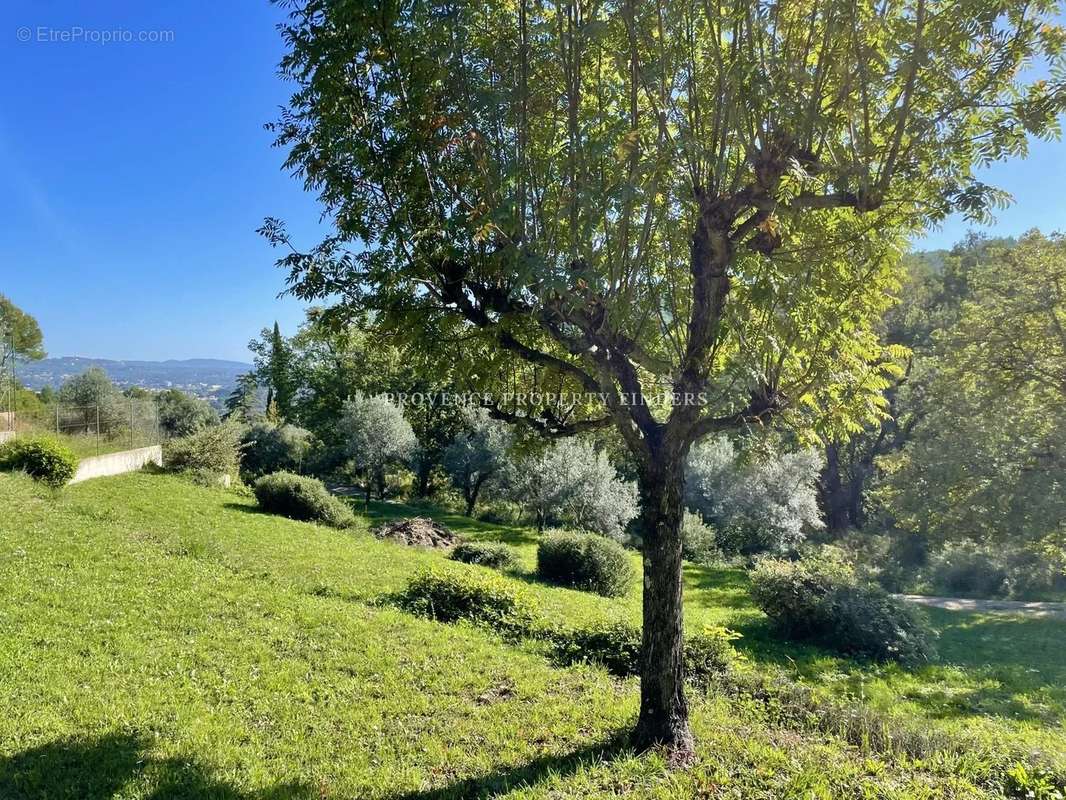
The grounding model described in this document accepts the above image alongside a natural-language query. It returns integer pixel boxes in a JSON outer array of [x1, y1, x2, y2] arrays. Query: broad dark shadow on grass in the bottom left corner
[[0, 733, 313, 800]]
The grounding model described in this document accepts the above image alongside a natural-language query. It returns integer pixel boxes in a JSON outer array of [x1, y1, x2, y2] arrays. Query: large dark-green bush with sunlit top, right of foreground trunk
[[752, 559, 934, 663]]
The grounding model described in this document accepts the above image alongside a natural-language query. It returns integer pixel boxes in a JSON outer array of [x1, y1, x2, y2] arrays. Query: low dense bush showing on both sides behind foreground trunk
[[547, 622, 739, 685]]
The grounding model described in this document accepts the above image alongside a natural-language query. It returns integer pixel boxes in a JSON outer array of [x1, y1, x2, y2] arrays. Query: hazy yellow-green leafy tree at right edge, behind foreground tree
[[875, 233, 1066, 546]]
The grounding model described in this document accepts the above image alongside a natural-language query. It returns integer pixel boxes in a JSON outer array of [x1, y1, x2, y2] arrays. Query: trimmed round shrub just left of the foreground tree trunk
[[536, 531, 633, 597]]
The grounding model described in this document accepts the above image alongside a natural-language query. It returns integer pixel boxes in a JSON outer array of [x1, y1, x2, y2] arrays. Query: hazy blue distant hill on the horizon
[[17, 356, 252, 397]]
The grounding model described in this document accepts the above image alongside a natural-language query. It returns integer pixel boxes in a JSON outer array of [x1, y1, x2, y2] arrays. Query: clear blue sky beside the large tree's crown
[[0, 0, 1066, 361]]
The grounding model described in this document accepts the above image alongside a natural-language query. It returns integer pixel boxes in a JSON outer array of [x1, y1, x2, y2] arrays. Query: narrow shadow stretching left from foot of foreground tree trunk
[[391, 732, 632, 800]]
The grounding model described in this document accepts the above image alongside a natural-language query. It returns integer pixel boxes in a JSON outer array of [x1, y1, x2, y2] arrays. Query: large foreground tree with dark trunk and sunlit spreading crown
[[263, 0, 1063, 757]]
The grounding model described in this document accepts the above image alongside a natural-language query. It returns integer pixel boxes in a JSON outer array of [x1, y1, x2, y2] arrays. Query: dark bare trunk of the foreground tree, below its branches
[[635, 457, 693, 763]]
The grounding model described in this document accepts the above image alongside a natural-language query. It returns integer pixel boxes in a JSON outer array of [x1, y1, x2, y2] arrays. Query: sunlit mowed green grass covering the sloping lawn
[[0, 474, 1066, 800]]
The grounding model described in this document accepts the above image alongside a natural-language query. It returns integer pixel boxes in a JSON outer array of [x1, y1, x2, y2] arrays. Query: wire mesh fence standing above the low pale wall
[[0, 397, 162, 457]]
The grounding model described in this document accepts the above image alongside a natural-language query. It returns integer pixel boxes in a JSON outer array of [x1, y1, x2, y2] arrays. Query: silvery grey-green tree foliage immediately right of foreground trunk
[[685, 435, 824, 556]]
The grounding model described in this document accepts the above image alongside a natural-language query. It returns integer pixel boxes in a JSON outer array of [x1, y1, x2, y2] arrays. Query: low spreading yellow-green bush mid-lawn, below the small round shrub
[[391, 570, 538, 636]]
